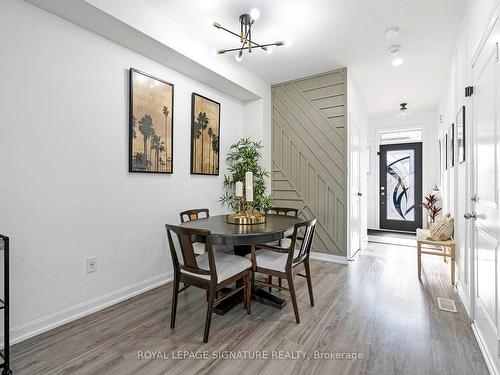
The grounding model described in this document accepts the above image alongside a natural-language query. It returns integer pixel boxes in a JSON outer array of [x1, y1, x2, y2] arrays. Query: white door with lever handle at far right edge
[[466, 15, 500, 365]]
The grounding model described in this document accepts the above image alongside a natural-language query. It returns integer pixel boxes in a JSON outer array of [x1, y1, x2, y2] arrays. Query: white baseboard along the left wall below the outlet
[[0, 272, 173, 345]]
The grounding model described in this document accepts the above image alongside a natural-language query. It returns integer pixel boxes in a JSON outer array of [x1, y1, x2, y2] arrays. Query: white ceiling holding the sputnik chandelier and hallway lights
[[143, 0, 466, 115]]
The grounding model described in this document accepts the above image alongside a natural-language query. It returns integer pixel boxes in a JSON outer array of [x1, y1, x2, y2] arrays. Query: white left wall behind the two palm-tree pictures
[[0, 0, 249, 341]]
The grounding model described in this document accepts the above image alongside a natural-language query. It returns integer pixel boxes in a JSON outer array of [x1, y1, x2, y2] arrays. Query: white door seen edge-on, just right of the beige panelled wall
[[348, 116, 361, 258]]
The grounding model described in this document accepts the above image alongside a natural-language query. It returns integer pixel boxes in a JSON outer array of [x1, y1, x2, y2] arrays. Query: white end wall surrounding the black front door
[[367, 109, 439, 229]]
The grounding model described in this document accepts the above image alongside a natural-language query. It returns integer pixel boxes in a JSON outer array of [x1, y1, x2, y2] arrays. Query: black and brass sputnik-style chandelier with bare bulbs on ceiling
[[213, 9, 289, 61]]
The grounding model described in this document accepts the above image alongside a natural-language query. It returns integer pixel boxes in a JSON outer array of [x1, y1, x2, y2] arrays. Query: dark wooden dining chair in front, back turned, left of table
[[165, 224, 252, 343]]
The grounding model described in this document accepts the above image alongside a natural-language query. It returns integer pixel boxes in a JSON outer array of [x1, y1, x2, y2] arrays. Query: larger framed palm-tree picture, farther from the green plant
[[129, 68, 174, 173]]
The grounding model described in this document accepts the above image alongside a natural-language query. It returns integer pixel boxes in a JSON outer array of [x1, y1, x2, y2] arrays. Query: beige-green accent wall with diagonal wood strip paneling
[[272, 69, 347, 255]]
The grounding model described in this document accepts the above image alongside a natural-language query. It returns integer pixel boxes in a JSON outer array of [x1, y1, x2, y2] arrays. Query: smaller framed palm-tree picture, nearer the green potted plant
[[191, 93, 220, 175]]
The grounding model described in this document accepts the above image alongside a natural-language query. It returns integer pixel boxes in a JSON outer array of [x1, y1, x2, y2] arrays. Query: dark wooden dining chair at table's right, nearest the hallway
[[247, 219, 316, 324]]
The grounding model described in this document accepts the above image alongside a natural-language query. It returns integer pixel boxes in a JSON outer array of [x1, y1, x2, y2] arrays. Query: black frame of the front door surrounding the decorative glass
[[377, 141, 424, 232]]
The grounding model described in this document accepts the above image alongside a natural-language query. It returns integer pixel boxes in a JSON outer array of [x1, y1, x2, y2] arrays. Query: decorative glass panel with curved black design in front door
[[385, 150, 415, 221]]
